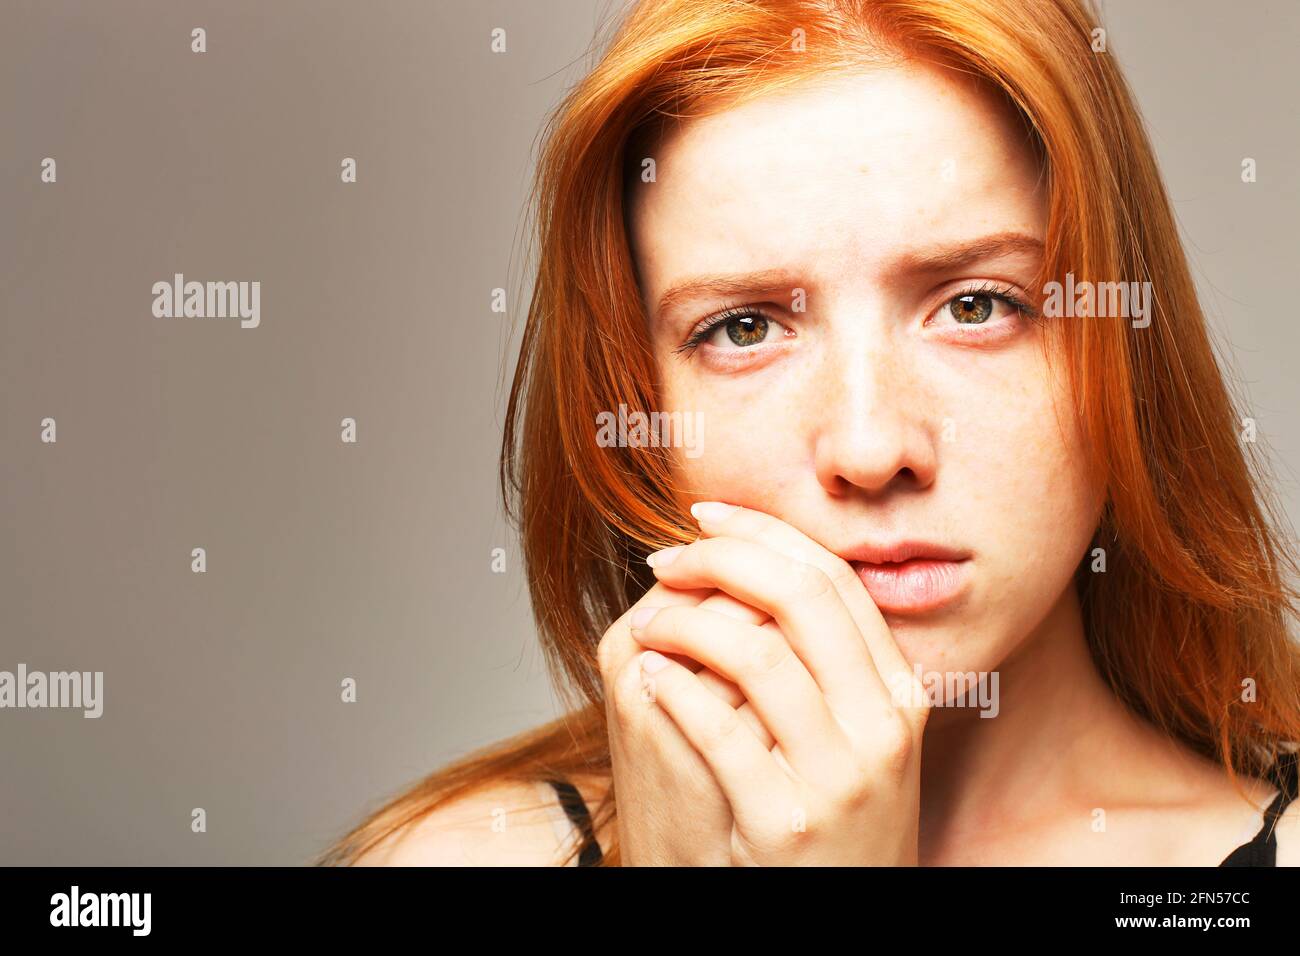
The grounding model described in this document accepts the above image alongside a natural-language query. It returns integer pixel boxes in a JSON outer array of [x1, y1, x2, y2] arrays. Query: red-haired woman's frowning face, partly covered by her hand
[[629, 65, 1100, 672]]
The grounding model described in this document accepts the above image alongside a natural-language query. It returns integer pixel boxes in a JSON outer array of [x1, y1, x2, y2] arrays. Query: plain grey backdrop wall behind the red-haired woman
[[0, 0, 1300, 865]]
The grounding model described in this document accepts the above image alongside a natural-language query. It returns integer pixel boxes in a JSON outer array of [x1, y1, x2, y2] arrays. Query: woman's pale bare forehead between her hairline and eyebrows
[[629, 64, 1044, 300]]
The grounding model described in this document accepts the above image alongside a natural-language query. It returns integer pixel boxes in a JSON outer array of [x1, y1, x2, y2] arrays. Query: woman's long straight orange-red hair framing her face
[[320, 0, 1300, 865]]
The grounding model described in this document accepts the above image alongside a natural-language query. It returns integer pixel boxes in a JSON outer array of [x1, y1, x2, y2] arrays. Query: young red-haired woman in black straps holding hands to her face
[[322, 0, 1300, 865]]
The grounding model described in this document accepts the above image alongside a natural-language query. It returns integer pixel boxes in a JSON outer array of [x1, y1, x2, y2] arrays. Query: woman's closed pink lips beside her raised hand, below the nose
[[846, 541, 970, 614]]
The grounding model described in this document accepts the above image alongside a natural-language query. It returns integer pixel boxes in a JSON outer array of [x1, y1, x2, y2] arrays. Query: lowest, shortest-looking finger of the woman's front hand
[[641, 650, 789, 818]]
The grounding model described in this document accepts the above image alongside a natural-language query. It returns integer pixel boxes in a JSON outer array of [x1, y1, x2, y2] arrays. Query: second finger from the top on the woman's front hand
[[647, 537, 889, 739]]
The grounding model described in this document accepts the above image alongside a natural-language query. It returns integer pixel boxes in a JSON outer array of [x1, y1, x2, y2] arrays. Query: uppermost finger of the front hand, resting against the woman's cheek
[[690, 501, 913, 702]]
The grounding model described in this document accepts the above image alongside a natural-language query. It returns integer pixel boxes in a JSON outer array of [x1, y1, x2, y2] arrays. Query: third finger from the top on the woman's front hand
[[632, 605, 849, 780]]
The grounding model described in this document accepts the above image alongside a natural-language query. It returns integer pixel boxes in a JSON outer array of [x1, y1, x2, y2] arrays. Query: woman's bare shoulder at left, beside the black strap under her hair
[[354, 780, 563, 866]]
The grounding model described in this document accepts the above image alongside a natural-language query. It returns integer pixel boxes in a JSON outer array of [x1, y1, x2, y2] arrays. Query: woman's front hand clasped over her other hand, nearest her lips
[[620, 503, 930, 865]]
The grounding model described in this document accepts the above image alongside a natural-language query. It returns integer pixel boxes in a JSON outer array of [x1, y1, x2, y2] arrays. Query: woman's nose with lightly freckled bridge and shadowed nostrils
[[810, 339, 941, 497]]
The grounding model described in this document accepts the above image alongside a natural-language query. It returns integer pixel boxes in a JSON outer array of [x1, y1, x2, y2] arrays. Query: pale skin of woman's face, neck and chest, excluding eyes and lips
[[618, 65, 1296, 866]]
